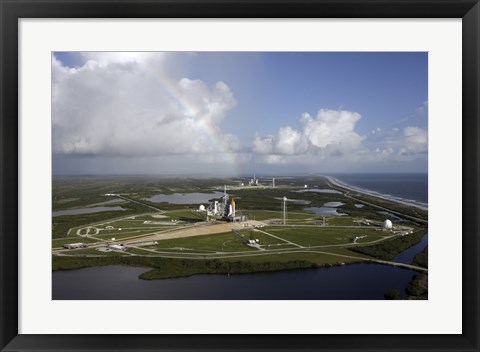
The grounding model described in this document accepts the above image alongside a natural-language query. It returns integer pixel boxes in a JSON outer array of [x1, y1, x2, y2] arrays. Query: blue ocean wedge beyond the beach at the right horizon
[[331, 173, 428, 205]]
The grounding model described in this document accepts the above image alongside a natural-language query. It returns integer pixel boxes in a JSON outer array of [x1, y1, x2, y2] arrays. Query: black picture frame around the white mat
[[0, 0, 480, 351]]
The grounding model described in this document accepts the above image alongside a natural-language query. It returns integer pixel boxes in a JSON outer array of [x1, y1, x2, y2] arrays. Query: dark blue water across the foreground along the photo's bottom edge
[[53, 264, 416, 300]]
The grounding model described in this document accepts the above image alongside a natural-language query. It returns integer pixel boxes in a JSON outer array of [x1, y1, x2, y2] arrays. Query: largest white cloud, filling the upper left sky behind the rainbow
[[52, 52, 241, 157]]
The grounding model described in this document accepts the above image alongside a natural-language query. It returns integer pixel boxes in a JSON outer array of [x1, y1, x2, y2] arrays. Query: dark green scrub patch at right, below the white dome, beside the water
[[350, 231, 425, 260]]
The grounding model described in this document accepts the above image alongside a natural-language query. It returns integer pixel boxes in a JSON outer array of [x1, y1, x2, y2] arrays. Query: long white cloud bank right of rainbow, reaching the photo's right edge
[[253, 109, 428, 170]]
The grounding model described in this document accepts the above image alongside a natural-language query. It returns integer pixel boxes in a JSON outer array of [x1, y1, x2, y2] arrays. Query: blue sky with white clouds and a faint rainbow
[[52, 52, 428, 176]]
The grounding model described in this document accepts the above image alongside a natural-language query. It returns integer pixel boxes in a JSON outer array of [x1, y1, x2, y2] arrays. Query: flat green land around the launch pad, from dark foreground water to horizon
[[52, 176, 428, 285]]
